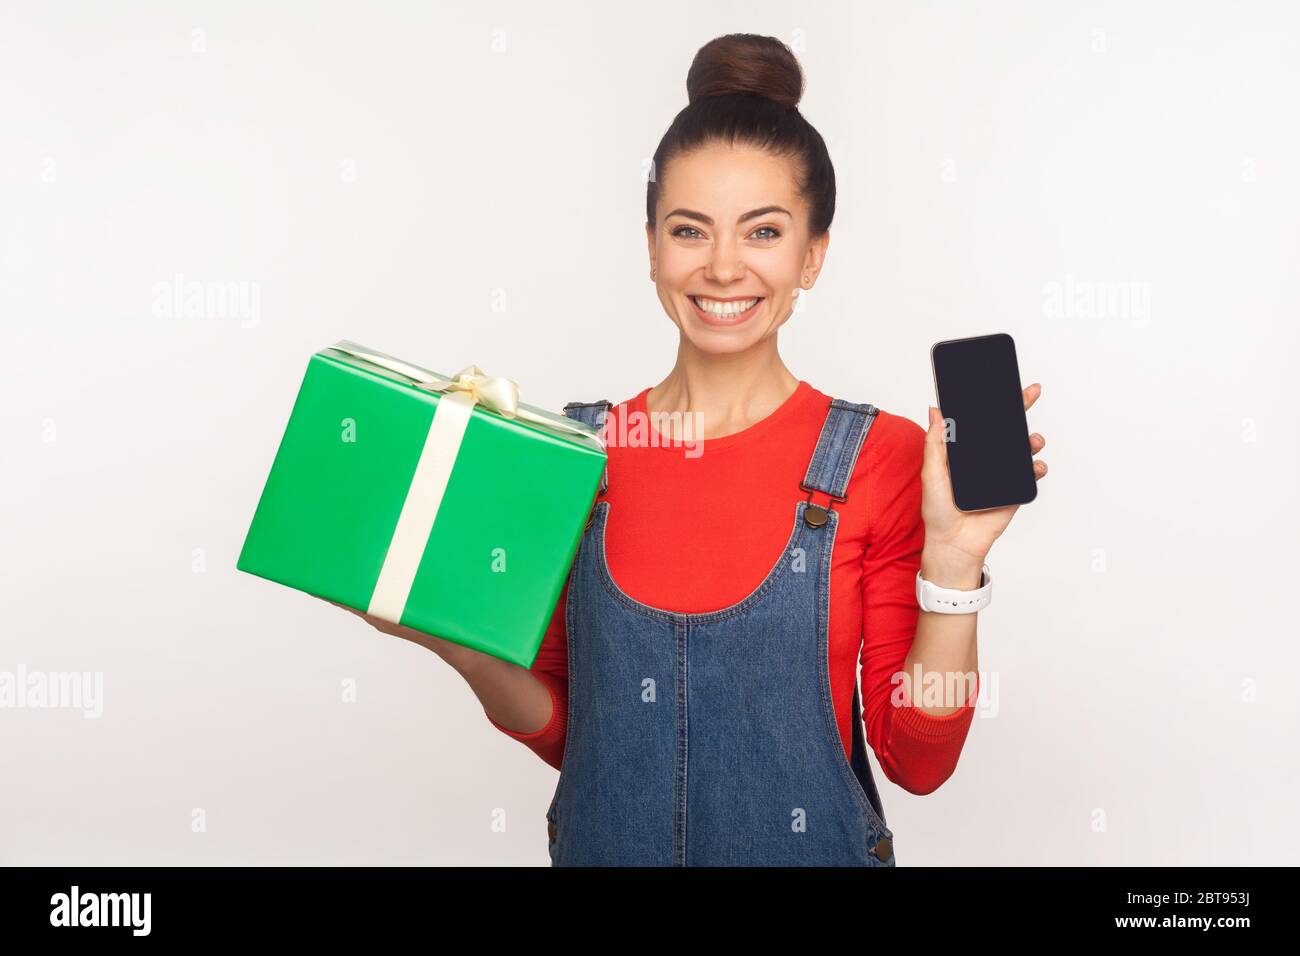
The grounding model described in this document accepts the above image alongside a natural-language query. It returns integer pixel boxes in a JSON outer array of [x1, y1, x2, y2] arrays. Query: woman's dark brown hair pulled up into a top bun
[[646, 34, 835, 237]]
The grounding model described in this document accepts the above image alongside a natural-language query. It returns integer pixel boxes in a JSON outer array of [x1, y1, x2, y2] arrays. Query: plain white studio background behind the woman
[[0, 0, 1300, 865]]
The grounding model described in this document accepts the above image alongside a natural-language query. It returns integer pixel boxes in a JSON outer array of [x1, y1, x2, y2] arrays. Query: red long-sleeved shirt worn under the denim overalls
[[488, 381, 978, 793]]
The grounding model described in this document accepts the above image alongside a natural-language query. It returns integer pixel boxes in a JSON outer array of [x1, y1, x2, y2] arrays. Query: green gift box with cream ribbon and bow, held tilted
[[235, 342, 606, 667]]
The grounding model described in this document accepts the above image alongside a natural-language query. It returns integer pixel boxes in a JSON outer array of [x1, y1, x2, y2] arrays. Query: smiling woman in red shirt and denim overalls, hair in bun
[[345, 34, 1047, 866]]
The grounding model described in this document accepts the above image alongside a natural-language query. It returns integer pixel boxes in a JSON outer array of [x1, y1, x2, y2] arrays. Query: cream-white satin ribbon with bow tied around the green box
[[330, 341, 605, 623]]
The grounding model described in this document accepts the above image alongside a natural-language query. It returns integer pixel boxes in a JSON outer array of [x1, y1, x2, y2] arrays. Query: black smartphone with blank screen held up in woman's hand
[[930, 332, 1039, 511]]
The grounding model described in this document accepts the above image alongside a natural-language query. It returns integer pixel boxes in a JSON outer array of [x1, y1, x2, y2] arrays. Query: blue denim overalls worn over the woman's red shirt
[[546, 399, 894, 866]]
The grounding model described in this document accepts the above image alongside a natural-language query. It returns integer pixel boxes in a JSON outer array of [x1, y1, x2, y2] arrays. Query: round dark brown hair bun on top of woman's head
[[686, 34, 803, 107]]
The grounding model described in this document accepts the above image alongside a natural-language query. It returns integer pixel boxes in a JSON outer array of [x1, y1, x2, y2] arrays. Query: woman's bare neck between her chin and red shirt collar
[[646, 336, 800, 438]]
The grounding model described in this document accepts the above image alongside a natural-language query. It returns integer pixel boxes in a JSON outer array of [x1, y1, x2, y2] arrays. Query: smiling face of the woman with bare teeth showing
[[646, 143, 831, 352]]
